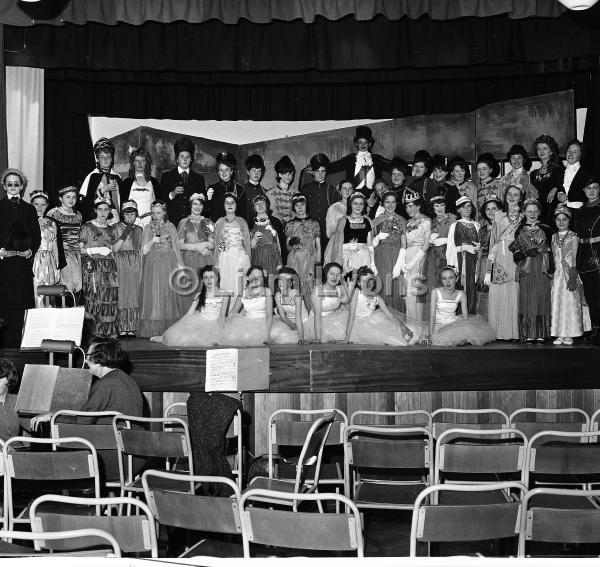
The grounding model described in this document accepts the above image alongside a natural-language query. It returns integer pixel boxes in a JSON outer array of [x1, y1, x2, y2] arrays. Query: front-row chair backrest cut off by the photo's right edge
[[519, 487, 600, 557]]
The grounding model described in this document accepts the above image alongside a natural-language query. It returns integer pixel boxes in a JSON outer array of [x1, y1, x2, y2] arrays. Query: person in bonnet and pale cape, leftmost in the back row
[[78, 138, 121, 224]]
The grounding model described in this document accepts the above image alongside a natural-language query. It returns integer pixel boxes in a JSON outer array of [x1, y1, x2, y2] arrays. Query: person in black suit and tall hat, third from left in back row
[[158, 138, 207, 226]]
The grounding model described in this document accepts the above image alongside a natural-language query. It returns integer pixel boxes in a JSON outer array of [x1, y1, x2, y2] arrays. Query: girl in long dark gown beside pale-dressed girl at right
[[512, 199, 552, 342]]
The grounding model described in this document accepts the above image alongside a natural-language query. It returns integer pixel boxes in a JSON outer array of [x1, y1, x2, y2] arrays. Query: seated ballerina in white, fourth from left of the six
[[305, 262, 350, 343]]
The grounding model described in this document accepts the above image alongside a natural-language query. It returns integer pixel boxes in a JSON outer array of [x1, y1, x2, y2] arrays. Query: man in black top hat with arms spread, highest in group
[[328, 126, 391, 197]]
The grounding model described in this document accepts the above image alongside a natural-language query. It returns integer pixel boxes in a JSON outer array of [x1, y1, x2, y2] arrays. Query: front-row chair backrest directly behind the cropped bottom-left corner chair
[[29, 494, 158, 557]]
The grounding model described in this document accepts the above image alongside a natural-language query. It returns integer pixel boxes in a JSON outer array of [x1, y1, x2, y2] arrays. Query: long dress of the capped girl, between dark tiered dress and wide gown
[[114, 222, 143, 333]]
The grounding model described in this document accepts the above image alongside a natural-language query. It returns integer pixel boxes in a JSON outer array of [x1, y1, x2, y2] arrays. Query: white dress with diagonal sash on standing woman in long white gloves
[[404, 215, 431, 321]]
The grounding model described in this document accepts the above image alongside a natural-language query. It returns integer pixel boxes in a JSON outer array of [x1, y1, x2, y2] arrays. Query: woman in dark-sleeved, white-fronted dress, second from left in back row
[[120, 146, 160, 228]]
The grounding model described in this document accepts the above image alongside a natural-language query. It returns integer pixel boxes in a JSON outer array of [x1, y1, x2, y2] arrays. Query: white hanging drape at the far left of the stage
[[6, 67, 44, 197]]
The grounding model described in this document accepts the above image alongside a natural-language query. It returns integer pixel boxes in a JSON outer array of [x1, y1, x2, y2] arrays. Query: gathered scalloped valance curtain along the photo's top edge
[[0, 0, 565, 26]]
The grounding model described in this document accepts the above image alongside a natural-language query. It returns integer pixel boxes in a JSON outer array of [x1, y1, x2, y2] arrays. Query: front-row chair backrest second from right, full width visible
[[410, 482, 526, 557]]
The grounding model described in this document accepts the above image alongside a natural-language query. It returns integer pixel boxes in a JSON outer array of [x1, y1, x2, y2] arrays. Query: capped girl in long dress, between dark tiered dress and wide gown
[[113, 201, 144, 337]]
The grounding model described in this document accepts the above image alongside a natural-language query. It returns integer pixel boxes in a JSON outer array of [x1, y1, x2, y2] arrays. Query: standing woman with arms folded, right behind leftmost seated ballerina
[[177, 193, 215, 315]]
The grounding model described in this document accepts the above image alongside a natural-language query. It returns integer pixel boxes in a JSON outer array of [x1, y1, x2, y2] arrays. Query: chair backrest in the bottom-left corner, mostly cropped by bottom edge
[[0, 528, 121, 557]]
